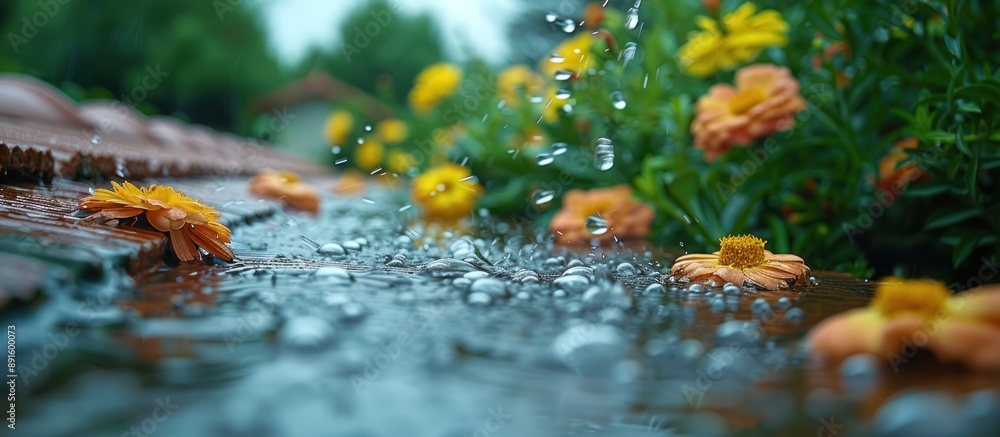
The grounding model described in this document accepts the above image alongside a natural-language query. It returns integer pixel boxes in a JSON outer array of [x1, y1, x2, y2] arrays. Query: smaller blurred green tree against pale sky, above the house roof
[[300, 0, 444, 102]]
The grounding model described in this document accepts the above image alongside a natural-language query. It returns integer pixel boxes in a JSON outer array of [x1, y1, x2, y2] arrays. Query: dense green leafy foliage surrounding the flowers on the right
[[408, 0, 1000, 280]]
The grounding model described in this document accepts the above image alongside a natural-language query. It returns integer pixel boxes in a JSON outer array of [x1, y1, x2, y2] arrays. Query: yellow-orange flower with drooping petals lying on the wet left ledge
[[79, 182, 234, 262]]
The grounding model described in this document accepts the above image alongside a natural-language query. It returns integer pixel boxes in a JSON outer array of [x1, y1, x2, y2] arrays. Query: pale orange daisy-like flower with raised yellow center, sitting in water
[[670, 235, 809, 290]]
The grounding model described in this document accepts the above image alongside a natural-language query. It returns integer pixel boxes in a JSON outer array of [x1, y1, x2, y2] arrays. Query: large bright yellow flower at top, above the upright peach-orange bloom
[[679, 3, 788, 77]]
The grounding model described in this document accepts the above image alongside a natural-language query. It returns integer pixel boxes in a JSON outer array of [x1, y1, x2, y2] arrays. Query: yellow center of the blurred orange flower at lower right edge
[[872, 278, 950, 319]]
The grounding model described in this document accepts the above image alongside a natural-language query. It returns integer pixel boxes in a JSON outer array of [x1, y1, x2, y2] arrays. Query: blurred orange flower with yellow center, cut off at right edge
[[808, 278, 1000, 373]]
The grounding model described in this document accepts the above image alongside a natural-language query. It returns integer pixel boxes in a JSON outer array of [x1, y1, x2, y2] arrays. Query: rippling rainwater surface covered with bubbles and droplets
[[10, 186, 1000, 436]]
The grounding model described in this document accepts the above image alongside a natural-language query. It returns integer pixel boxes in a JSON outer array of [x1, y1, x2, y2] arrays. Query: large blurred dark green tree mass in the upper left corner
[[0, 0, 287, 129]]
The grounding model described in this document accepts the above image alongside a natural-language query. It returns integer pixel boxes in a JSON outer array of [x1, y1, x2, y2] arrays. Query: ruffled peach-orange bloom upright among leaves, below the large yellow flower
[[691, 64, 806, 162]]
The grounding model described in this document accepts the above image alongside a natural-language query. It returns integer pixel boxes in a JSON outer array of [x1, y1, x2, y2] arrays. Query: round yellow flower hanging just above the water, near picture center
[[410, 163, 483, 221]]
